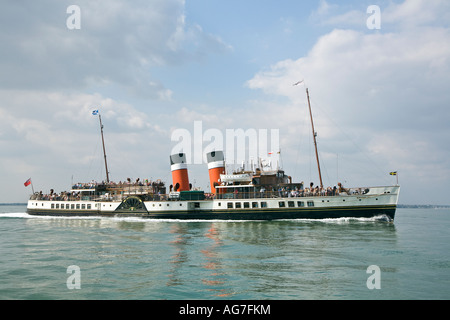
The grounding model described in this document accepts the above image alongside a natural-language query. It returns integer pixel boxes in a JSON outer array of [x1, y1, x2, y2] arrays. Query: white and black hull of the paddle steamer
[[27, 187, 399, 221]]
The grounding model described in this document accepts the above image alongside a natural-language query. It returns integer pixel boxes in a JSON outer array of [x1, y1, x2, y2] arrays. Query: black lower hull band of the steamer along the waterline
[[27, 205, 396, 221]]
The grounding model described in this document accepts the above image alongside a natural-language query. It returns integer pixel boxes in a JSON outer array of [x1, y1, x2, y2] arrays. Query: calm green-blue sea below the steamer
[[0, 205, 450, 300]]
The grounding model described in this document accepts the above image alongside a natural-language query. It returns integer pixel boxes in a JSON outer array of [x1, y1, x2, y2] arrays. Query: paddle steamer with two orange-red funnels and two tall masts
[[27, 85, 400, 221]]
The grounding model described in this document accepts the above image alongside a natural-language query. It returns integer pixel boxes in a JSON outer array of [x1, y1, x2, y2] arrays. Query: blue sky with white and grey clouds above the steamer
[[0, 0, 450, 205]]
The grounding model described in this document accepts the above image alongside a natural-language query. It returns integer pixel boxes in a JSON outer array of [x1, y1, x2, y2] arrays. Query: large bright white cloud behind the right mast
[[247, 1, 450, 202]]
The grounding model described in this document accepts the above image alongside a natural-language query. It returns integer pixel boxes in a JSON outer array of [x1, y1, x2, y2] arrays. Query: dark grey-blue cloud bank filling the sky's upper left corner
[[0, 0, 228, 99]]
